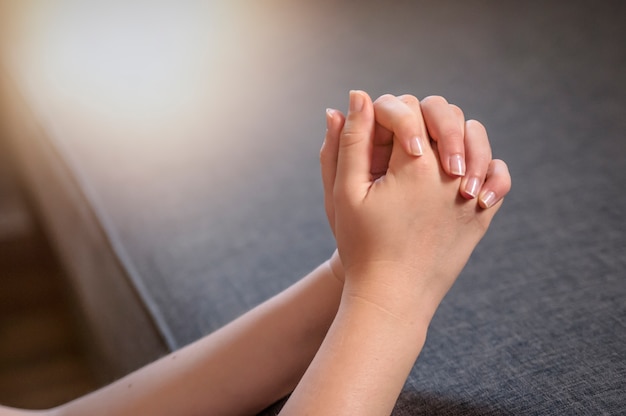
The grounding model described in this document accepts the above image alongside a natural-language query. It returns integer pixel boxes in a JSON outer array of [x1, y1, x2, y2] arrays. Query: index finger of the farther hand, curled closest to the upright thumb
[[374, 94, 428, 156]]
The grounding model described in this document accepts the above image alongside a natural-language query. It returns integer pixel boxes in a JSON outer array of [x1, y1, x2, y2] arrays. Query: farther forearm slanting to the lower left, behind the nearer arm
[[54, 263, 342, 416]]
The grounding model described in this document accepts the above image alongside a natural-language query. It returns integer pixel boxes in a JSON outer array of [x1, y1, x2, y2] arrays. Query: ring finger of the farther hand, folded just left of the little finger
[[460, 120, 491, 199]]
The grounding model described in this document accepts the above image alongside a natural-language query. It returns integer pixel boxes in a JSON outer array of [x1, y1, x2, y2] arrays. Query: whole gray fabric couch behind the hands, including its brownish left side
[[2, 1, 626, 416]]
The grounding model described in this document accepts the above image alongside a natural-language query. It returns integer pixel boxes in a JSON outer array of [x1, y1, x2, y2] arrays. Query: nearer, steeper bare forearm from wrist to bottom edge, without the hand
[[281, 272, 428, 416]]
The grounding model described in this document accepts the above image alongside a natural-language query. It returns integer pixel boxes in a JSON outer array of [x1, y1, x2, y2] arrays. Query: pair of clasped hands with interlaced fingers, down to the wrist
[[320, 91, 511, 319]]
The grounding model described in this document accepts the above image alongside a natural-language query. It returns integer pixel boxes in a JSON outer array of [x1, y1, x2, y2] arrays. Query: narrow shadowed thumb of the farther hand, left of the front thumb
[[320, 108, 345, 234]]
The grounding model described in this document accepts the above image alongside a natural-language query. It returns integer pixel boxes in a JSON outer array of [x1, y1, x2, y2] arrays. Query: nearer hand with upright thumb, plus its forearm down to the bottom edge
[[281, 92, 510, 416]]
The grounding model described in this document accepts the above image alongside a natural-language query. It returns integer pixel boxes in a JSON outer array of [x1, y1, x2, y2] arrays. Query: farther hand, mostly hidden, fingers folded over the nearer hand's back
[[320, 95, 510, 290]]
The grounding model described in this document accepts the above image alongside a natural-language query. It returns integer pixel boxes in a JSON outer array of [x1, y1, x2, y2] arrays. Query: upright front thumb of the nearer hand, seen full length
[[335, 91, 374, 199]]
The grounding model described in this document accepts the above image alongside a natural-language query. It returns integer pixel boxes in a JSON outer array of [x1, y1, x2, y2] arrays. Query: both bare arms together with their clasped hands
[[0, 91, 510, 416]]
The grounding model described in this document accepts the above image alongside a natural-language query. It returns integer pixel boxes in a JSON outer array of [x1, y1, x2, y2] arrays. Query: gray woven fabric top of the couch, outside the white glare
[[2, 1, 626, 416]]
